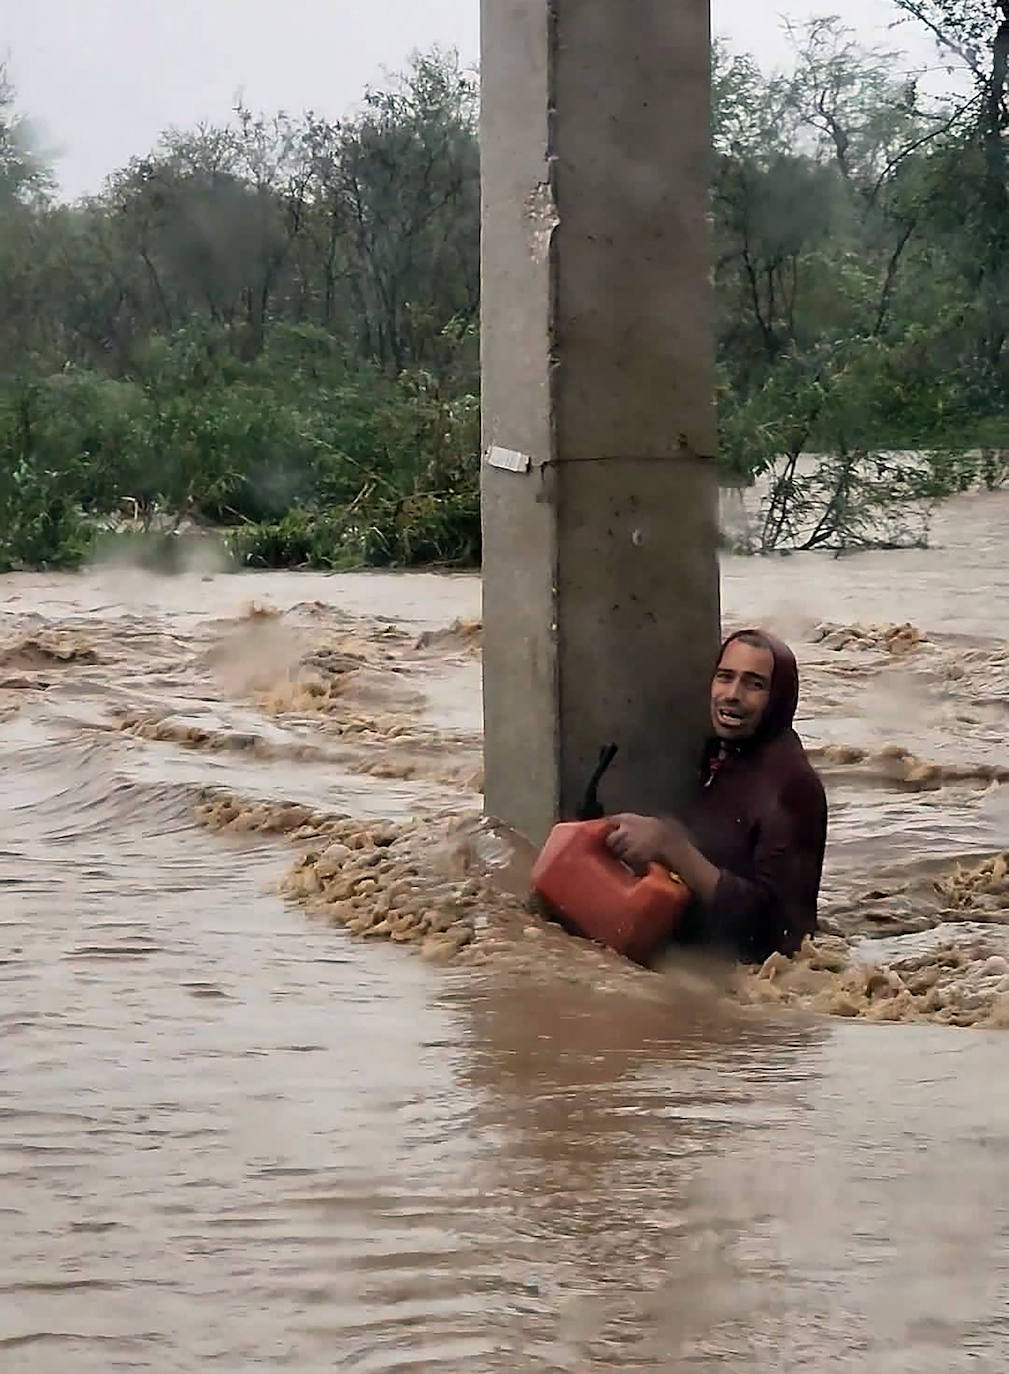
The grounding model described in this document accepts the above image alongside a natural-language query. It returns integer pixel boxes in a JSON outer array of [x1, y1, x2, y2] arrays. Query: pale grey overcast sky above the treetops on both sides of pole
[[0, 0, 933, 196]]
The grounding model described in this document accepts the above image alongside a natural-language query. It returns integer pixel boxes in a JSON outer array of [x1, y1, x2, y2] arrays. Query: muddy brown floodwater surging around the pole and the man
[[0, 495, 1009, 1374]]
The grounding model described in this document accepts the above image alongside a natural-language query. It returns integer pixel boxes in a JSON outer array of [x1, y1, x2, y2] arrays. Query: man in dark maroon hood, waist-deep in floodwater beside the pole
[[608, 629, 828, 963]]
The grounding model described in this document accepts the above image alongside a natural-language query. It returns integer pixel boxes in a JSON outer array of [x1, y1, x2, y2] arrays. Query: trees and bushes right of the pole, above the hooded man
[[713, 14, 1009, 551]]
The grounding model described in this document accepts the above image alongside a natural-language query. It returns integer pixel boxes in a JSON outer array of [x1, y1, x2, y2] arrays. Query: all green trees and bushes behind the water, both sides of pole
[[0, 0, 1009, 569]]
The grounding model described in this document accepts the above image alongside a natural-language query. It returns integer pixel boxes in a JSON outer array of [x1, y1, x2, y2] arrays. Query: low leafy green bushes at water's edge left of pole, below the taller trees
[[0, 326, 480, 567]]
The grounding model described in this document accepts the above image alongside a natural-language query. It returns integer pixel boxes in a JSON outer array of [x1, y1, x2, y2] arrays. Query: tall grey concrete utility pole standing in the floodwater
[[481, 0, 719, 842]]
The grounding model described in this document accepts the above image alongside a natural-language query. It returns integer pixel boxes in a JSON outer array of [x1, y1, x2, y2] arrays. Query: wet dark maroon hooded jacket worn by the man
[[680, 631, 826, 963]]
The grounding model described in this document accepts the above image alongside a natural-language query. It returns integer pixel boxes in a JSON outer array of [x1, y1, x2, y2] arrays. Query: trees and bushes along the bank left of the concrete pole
[[0, 54, 480, 566]]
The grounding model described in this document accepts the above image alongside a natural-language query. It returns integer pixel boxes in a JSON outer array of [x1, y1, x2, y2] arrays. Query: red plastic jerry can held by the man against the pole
[[532, 820, 690, 963]]
